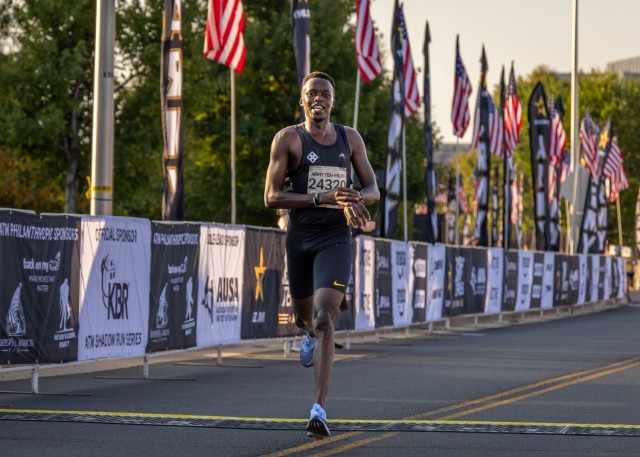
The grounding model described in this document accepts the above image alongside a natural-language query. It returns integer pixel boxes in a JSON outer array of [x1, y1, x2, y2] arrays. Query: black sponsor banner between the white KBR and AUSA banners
[[147, 222, 200, 352]]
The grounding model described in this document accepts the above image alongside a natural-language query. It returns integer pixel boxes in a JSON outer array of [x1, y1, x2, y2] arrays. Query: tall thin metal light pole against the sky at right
[[567, 0, 583, 254]]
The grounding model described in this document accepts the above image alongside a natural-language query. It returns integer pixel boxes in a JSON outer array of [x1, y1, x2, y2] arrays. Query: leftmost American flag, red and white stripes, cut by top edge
[[204, 0, 247, 73]]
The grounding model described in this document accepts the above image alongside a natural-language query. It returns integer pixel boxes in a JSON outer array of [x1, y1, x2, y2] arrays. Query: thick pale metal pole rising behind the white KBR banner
[[89, 0, 116, 216]]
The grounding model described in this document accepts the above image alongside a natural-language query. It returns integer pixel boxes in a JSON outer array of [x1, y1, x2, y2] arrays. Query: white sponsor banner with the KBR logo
[[78, 217, 151, 360]]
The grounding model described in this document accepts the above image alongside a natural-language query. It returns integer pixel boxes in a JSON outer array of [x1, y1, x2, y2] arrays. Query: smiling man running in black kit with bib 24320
[[264, 72, 380, 439]]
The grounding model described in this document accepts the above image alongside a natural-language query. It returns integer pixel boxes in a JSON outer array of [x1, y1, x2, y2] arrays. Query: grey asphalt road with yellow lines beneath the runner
[[0, 305, 640, 457]]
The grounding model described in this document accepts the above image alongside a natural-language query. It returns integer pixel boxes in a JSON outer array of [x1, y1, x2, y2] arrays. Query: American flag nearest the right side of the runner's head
[[355, 0, 382, 83]]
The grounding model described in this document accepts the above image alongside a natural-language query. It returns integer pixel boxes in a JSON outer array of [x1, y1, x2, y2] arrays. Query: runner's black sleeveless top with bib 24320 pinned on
[[287, 124, 351, 226]]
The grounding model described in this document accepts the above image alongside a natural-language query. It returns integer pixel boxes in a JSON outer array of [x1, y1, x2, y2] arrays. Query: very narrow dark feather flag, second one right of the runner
[[422, 22, 438, 243]]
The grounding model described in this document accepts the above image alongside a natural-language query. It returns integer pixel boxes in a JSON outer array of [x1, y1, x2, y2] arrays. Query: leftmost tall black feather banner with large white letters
[[160, 0, 184, 221]]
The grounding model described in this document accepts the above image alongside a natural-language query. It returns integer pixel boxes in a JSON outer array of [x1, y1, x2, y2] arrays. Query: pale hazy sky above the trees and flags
[[364, 0, 640, 143]]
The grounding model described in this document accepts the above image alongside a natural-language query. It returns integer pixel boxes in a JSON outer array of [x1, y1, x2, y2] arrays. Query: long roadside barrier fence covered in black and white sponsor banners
[[0, 210, 627, 364]]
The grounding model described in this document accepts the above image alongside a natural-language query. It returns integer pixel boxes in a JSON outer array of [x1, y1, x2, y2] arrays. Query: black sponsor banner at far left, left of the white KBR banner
[[0, 212, 80, 363]]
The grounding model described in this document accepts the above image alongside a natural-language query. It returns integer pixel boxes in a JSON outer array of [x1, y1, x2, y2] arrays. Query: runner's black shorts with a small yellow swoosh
[[286, 221, 353, 298]]
